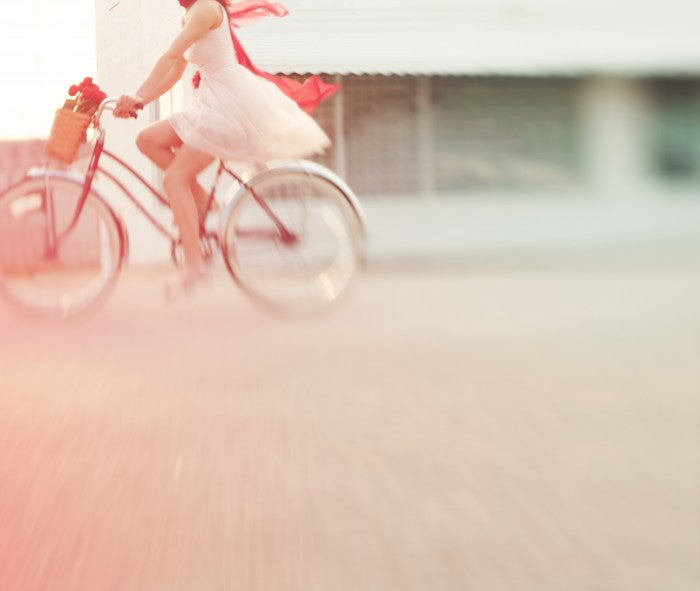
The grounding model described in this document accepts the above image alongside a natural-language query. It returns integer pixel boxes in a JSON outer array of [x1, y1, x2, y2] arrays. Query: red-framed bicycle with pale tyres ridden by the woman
[[0, 97, 366, 318]]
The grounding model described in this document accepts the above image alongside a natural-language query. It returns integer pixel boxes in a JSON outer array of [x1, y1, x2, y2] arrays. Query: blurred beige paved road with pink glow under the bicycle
[[0, 264, 700, 591]]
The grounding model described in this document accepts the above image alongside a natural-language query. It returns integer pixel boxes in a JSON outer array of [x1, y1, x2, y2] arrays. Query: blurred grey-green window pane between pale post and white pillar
[[432, 77, 580, 193]]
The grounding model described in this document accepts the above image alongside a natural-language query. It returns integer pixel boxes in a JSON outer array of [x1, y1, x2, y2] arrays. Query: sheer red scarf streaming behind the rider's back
[[179, 0, 340, 115]]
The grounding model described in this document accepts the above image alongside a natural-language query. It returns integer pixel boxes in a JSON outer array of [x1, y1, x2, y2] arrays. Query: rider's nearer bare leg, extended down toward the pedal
[[163, 145, 214, 280]]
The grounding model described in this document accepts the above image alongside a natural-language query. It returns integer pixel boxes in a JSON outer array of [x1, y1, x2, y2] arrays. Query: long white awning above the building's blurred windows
[[240, 0, 700, 75]]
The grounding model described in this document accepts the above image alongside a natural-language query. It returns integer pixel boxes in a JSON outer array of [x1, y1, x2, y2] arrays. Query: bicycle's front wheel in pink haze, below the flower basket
[[0, 175, 125, 318]]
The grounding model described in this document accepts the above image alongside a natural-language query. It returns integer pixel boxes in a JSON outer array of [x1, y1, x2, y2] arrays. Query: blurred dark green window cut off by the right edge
[[651, 79, 700, 182]]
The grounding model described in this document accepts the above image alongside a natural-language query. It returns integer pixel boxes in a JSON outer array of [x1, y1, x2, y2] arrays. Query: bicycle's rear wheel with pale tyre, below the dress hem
[[221, 168, 365, 316]]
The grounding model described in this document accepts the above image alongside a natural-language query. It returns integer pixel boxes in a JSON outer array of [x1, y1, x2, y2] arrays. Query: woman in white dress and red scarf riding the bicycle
[[114, 0, 337, 292]]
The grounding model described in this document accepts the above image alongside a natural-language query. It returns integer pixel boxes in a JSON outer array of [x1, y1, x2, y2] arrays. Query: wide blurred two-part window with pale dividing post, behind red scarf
[[300, 75, 583, 197]]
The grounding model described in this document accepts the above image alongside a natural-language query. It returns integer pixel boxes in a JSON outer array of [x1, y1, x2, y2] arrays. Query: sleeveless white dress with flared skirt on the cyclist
[[168, 7, 331, 162]]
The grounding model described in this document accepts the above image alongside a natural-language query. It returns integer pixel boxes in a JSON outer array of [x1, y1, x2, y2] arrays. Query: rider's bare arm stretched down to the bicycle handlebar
[[114, 0, 222, 116]]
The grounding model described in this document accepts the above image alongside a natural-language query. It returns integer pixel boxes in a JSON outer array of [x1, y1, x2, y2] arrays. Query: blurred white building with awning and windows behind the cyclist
[[96, 0, 700, 260]]
